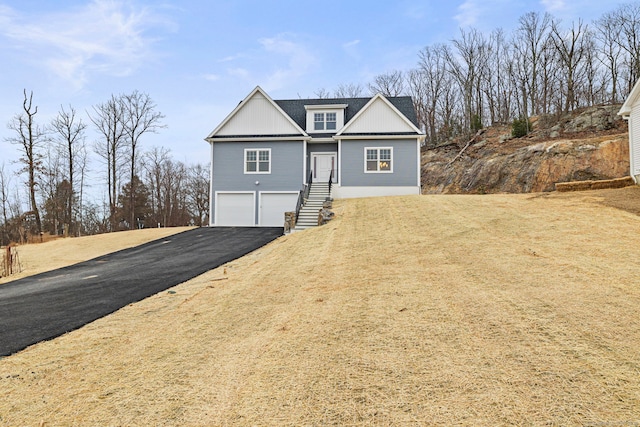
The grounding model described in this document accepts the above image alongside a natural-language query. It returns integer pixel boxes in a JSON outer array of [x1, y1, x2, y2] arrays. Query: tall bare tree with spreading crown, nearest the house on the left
[[122, 90, 165, 231]]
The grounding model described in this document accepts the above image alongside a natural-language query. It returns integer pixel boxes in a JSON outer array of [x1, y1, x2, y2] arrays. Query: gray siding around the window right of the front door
[[340, 139, 418, 187]]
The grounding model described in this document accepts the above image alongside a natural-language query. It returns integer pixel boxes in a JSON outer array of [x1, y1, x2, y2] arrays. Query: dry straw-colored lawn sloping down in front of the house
[[0, 191, 640, 426]]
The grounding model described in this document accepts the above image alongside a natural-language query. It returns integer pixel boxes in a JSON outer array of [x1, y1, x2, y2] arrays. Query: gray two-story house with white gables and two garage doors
[[206, 87, 424, 226]]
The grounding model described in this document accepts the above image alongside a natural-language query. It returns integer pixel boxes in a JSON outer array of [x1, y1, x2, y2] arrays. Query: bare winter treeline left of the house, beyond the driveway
[[0, 90, 209, 245]]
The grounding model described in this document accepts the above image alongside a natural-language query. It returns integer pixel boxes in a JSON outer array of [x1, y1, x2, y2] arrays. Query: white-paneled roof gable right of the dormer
[[336, 94, 421, 136]]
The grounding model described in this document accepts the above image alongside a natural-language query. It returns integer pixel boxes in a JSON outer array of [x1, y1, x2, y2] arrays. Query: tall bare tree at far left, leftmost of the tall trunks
[[6, 89, 46, 234]]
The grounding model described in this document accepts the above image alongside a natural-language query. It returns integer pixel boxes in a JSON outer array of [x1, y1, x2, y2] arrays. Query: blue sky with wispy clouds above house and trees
[[0, 0, 624, 197]]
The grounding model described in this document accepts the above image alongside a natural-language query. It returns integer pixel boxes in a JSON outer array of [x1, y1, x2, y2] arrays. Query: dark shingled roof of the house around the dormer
[[274, 96, 418, 129]]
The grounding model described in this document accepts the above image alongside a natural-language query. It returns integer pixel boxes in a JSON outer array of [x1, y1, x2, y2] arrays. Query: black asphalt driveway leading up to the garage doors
[[0, 227, 283, 356]]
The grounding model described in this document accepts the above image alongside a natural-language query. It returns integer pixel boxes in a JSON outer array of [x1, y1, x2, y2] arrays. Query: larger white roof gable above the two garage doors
[[207, 86, 306, 138]]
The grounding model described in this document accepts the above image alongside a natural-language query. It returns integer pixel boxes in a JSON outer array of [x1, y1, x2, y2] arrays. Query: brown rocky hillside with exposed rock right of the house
[[422, 105, 629, 194]]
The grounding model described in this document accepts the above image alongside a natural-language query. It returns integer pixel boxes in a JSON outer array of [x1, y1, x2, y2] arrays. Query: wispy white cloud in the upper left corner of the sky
[[0, 0, 174, 88]]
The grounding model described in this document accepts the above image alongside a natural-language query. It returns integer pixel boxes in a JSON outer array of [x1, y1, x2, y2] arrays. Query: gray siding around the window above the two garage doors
[[211, 141, 304, 224]]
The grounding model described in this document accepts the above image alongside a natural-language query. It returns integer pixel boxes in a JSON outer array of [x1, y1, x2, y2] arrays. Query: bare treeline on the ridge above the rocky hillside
[[324, 2, 640, 146]]
